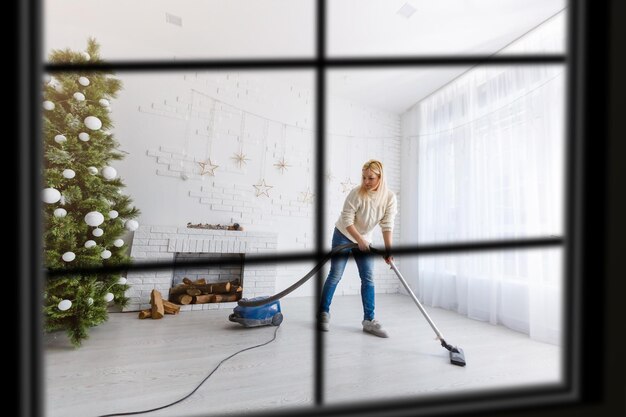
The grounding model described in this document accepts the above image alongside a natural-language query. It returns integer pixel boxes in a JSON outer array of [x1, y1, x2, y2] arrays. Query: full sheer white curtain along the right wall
[[406, 13, 566, 344]]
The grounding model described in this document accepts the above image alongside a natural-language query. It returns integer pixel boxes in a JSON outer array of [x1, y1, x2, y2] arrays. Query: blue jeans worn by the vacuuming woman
[[320, 228, 374, 320]]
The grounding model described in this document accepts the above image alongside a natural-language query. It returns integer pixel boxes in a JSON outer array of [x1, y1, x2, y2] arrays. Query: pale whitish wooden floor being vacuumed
[[44, 294, 561, 417]]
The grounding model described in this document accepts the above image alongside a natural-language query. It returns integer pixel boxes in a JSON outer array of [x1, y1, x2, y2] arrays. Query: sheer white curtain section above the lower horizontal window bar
[[404, 66, 566, 243]]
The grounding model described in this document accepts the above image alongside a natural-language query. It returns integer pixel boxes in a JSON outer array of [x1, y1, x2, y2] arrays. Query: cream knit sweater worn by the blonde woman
[[335, 186, 398, 243]]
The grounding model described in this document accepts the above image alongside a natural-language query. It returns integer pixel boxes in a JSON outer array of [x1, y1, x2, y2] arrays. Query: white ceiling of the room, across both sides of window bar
[[43, 0, 566, 113]]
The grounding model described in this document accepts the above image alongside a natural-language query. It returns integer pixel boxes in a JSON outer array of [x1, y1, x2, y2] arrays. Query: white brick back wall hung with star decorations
[[111, 71, 401, 296]]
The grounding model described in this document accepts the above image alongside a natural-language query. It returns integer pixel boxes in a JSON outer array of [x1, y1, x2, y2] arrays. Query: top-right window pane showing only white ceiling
[[328, 0, 567, 57]]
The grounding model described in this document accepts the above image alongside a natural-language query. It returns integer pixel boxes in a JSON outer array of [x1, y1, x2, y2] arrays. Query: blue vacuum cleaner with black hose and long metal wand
[[236, 243, 465, 366]]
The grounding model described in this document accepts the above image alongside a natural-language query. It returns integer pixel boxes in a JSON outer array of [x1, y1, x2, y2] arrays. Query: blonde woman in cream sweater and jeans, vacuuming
[[318, 159, 397, 337]]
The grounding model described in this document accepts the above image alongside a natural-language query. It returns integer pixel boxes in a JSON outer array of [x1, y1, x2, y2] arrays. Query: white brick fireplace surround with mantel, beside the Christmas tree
[[124, 225, 277, 311]]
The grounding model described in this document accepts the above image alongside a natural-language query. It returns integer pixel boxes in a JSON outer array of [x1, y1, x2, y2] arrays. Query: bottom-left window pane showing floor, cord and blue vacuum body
[[43, 263, 314, 417]]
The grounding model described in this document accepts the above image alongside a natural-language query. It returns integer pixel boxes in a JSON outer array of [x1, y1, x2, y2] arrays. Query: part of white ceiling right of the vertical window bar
[[328, 0, 566, 114]]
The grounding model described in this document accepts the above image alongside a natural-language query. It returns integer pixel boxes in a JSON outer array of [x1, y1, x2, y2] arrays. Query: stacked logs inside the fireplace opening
[[169, 277, 243, 305]]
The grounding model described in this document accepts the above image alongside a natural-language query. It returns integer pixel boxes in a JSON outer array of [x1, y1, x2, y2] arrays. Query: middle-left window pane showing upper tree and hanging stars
[[42, 71, 315, 268]]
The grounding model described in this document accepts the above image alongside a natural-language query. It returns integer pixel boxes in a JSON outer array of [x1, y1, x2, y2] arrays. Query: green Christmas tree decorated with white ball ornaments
[[42, 39, 139, 346]]
